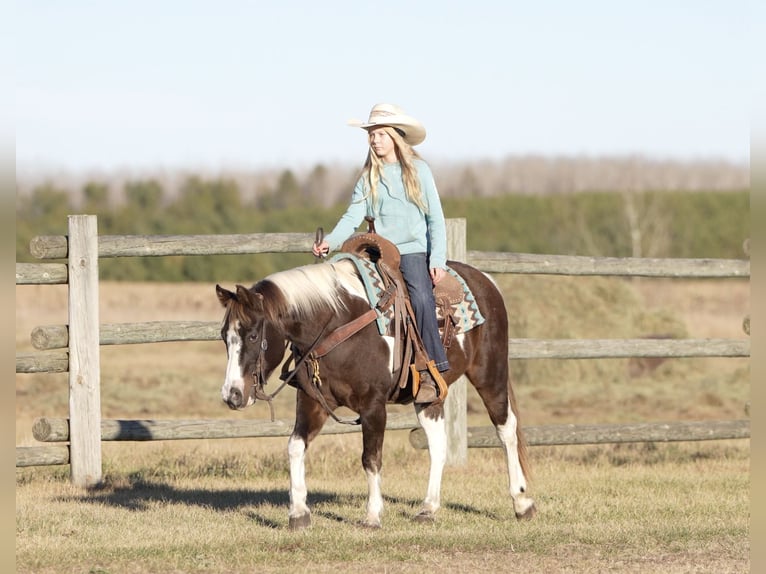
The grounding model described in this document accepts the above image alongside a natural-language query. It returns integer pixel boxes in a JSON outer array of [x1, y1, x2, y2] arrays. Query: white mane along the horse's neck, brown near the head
[[254, 260, 365, 320]]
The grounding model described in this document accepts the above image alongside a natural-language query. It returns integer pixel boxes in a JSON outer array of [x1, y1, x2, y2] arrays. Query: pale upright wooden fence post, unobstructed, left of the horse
[[68, 215, 102, 487]]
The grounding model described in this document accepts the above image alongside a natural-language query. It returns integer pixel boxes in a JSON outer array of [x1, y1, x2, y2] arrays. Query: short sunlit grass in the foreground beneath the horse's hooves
[[16, 438, 749, 573]]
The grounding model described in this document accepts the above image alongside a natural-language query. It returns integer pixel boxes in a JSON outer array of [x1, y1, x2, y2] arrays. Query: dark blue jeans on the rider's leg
[[399, 253, 449, 372]]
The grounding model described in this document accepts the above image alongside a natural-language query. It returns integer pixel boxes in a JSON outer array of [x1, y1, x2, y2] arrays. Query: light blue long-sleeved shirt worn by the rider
[[325, 159, 447, 269]]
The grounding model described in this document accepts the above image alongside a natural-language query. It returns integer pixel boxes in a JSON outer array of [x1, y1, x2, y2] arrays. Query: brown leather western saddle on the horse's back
[[339, 216, 463, 401]]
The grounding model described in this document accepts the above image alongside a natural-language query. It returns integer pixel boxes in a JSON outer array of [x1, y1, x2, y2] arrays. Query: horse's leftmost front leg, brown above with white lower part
[[287, 390, 327, 530]]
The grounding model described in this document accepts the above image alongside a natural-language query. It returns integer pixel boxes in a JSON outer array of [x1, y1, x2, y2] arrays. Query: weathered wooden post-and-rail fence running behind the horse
[[16, 215, 750, 486]]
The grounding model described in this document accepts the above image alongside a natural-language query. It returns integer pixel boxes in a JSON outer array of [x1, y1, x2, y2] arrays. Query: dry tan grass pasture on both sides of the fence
[[16, 276, 750, 573]]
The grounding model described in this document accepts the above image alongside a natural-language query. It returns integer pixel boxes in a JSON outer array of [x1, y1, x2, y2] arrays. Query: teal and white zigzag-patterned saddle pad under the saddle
[[328, 253, 485, 335]]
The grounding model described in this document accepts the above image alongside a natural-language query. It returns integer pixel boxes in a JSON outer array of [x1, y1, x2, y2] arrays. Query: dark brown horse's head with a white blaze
[[215, 285, 285, 409]]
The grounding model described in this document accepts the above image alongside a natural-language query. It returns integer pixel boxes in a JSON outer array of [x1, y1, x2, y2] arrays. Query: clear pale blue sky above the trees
[[14, 0, 754, 171]]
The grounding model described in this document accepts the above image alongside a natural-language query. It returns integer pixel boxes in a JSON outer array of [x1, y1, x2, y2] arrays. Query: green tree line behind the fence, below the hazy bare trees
[[16, 158, 750, 282]]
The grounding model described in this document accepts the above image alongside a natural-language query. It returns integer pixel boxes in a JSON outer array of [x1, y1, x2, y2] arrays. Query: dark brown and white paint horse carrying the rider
[[216, 260, 536, 530]]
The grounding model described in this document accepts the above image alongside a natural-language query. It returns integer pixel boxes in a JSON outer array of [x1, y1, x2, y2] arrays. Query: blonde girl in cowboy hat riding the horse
[[312, 104, 449, 403]]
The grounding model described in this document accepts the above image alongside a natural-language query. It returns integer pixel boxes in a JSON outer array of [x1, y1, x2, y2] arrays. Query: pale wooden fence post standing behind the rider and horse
[[444, 217, 468, 466]]
